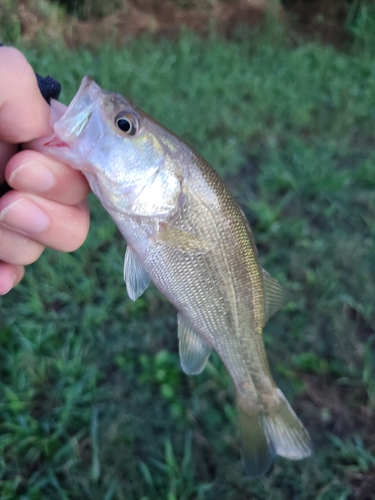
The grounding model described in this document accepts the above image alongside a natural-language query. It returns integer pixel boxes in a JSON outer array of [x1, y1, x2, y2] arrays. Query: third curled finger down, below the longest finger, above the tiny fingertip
[[0, 224, 44, 266]]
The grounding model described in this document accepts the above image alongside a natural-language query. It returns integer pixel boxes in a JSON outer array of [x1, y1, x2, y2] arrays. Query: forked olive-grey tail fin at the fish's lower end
[[237, 389, 312, 477]]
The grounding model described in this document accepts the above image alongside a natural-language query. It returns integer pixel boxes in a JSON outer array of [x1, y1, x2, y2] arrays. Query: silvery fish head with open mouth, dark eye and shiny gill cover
[[32, 76, 182, 212]]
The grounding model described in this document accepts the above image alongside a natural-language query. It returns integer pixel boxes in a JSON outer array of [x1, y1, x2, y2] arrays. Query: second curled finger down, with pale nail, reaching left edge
[[0, 191, 90, 252]]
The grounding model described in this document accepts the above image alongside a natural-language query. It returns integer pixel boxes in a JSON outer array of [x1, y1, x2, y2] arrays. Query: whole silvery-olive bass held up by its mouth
[[32, 76, 313, 477]]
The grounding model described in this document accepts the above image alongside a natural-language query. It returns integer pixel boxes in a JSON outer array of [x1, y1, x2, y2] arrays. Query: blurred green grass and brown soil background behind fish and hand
[[0, 0, 375, 500]]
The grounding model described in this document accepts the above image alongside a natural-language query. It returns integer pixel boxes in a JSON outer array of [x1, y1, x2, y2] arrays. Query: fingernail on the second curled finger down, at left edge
[[0, 198, 49, 233]]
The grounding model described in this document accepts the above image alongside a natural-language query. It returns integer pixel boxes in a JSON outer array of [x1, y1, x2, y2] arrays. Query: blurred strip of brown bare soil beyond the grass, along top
[[7, 0, 356, 47]]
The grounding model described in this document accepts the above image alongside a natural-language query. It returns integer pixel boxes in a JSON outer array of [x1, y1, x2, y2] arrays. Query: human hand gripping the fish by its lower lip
[[0, 47, 89, 295]]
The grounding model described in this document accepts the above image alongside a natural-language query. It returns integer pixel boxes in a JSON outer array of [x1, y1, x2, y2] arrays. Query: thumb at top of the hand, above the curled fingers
[[0, 47, 52, 144]]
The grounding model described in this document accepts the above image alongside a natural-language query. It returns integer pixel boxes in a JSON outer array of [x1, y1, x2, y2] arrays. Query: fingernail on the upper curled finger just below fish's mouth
[[9, 160, 56, 193]]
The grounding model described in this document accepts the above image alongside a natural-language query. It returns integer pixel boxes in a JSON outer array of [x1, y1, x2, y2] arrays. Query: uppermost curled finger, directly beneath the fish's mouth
[[6, 150, 90, 205]]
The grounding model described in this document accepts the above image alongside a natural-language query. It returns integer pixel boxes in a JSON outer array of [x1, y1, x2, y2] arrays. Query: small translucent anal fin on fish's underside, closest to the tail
[[177, 314, 211, 375]]
